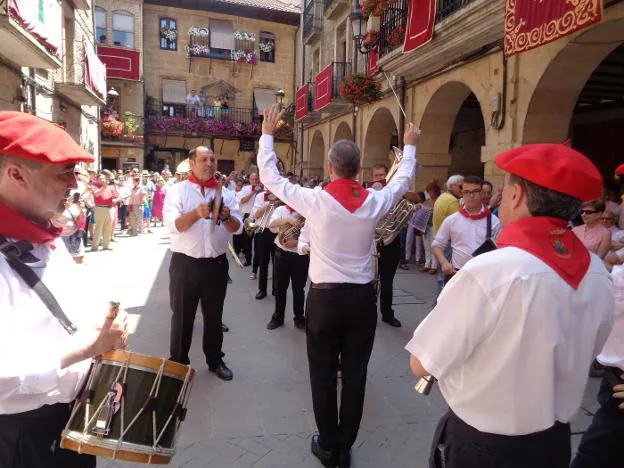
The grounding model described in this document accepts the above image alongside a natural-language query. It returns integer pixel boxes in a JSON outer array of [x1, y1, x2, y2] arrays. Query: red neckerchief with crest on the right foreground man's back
[[496, 216, 591, 289]]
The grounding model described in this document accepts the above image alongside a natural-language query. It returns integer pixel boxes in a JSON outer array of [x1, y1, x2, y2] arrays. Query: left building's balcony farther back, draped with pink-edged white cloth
[[55, 42, 106, 106]]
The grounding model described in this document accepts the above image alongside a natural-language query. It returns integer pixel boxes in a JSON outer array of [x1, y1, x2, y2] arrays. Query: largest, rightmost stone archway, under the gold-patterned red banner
[[522, 18, 624, 180]]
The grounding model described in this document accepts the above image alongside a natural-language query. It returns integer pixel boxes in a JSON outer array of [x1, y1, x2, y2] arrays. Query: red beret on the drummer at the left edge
[[0, 111, 94, 164]]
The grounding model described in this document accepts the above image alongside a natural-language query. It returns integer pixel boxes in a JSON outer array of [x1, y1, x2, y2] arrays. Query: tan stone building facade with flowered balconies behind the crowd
[[143, 0, 300, 173]]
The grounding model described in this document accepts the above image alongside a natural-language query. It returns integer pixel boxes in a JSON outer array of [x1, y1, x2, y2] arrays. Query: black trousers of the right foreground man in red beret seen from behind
[[429, 411, 570, 468]]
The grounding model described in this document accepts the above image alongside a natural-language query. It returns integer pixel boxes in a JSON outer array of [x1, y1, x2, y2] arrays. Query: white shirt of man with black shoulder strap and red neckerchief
[[432, 211, 500, 269]]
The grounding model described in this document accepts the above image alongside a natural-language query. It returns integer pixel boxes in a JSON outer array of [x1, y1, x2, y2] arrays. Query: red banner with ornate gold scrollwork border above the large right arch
[[505, 0, 603, 56]]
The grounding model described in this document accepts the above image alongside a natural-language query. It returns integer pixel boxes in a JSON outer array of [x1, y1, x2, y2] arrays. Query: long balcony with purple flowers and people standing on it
[[145, 102, 294, 141]]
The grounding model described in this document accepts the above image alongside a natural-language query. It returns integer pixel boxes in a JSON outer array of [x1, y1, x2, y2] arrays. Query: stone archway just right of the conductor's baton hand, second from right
[[419, 81, 485, 182]]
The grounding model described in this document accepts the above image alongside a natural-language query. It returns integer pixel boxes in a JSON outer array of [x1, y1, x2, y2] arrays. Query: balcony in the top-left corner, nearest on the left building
[[0, 0, 63, 70]]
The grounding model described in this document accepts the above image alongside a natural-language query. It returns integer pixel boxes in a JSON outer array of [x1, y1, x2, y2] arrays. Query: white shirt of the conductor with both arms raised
[[258, 135, 416, 284]]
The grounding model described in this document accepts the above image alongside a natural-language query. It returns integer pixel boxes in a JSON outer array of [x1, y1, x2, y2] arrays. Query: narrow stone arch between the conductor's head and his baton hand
[[362, 107, 399, 181]]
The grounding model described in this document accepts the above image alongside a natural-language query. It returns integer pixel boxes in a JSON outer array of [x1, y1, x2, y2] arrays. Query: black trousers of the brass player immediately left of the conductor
[[273, 247, 310, 320]]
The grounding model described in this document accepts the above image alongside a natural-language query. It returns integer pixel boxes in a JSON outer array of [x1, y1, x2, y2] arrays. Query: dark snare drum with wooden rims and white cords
[[61, 350, 195, 464]]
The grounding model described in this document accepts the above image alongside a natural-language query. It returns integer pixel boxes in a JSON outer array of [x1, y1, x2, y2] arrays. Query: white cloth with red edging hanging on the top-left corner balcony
[[8, 0, 63, 57]]
